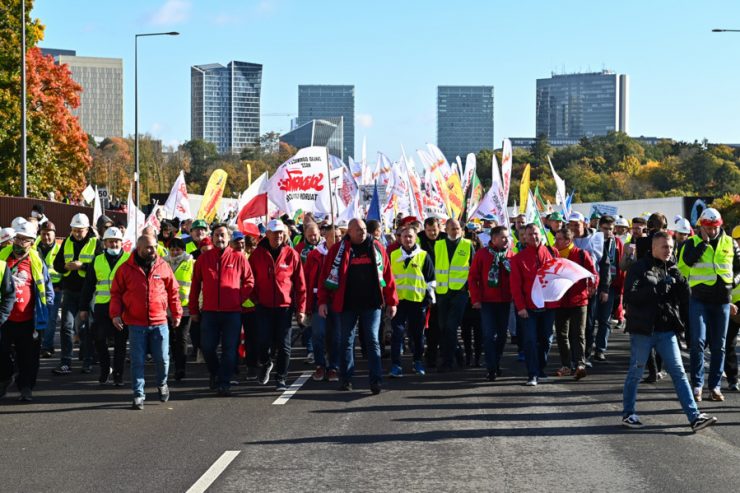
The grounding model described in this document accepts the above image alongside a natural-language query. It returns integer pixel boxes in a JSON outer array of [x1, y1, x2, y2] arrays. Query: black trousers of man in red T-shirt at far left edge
[[0, 319, 41, 390]]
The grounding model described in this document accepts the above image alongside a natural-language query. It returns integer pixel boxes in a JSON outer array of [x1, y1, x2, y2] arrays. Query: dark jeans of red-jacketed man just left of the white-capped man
[[200, 311, 242, 389]]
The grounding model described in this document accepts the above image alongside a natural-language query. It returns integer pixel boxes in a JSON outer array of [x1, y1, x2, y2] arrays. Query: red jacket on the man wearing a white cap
[[249, 238, 306, 313]]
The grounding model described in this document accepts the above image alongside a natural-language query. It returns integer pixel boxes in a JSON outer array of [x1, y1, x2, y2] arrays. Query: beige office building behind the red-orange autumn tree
[[41, 48, 123, 138]]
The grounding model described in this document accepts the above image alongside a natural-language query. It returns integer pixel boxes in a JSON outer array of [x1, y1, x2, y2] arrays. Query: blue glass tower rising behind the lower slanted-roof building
[[297, 85, 355, 160]]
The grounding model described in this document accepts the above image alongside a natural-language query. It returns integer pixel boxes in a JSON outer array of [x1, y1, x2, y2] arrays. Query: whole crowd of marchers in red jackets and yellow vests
[[0, 201, 740, 430]]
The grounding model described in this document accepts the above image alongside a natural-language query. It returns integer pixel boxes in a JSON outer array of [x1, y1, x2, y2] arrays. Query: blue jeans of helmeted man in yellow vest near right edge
[[689, 298, 730, 390]]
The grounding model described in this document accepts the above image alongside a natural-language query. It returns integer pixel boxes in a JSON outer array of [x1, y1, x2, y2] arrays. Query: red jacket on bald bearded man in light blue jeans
[[108, 254, 182, 326]]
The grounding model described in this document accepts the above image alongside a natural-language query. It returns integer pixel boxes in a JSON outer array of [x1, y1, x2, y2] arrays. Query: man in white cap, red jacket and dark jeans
[[249, 219, 306, 391]]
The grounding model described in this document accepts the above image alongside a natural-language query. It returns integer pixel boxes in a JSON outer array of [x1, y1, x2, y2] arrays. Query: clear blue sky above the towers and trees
[[32, 0, 740, 159]]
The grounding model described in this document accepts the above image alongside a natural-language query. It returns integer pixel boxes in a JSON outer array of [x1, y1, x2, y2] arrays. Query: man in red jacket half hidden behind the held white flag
[[555, 228, 599, 380]]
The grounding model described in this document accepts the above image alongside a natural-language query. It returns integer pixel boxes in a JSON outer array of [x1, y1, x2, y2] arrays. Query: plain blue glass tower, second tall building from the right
[[437, 86, 493, 162]]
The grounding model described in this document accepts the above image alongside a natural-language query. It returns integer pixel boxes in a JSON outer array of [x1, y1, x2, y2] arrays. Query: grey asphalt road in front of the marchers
[[0, 333, 740, 492]]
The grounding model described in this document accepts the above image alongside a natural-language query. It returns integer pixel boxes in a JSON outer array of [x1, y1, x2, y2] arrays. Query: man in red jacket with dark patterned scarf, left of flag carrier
[[468, 226, 512, 382]]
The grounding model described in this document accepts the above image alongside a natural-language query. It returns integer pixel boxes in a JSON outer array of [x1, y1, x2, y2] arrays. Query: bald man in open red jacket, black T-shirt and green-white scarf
[[318, 219, 398, 395]]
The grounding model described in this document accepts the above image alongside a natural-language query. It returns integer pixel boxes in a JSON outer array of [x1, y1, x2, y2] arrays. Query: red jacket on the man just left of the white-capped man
[[188, 247, 254, 315]]
